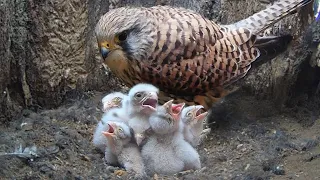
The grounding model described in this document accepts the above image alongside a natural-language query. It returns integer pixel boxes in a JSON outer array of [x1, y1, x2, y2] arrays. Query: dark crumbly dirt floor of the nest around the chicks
[[0, 88, 320, 180]]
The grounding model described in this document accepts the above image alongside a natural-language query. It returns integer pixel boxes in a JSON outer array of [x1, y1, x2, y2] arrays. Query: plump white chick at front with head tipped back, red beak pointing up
[[141, 100, 201, 176]]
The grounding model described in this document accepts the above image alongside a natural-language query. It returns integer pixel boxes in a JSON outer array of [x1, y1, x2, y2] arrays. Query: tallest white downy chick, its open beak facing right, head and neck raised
[[126, 83, 159, 146]]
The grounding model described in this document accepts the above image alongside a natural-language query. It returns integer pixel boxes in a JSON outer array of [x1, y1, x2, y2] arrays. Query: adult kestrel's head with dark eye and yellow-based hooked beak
[[95, 7, 157, 63]]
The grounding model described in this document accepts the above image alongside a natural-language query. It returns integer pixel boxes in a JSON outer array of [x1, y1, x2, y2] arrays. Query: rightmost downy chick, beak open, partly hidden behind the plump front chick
[[180, 105, 208, 147]]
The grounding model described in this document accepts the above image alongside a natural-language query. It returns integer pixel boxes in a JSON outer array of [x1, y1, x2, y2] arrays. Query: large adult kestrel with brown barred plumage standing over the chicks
[[96, 0, 312, 110]]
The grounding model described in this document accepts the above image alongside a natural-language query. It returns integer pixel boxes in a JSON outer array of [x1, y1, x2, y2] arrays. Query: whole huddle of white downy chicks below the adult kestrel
[[93, 84, 208, 178]]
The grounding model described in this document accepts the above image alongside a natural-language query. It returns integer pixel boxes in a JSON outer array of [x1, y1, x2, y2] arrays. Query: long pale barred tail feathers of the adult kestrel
[[222, 0, 313, 34]]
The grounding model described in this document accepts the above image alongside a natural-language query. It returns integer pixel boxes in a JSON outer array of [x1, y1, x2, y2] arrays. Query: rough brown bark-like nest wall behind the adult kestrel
[[0, 0, 319, 122]]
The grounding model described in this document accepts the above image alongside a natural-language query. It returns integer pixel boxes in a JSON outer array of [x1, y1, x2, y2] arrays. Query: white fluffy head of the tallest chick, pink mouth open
[[128, 83, 159, 115]]
